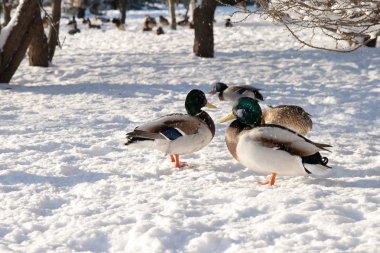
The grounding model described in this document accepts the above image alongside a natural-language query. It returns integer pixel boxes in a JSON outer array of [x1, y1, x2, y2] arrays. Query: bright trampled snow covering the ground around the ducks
[[0, 7, 380, 253]]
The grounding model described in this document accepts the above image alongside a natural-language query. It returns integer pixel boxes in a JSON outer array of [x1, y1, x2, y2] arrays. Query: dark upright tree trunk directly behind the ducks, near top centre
[[193, 0, 216, 58]]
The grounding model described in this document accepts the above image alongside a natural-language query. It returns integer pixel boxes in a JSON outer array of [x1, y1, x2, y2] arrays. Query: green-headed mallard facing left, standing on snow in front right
[[221, 97, 331, 185]]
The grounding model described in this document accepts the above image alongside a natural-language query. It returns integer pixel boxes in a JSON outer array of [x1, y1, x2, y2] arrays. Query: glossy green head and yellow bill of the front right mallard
[[220, 97, 263, 127]]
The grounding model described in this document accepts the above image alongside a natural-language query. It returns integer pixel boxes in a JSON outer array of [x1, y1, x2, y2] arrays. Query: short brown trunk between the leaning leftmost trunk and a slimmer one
[[29, 9, 49, 67]]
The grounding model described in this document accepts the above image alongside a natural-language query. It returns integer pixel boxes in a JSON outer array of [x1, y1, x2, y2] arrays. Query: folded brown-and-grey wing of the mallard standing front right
[[248, 125, 331, 156]]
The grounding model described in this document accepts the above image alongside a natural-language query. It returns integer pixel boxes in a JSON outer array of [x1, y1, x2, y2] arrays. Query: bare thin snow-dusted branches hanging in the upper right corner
[[247, 0, 380, 52]]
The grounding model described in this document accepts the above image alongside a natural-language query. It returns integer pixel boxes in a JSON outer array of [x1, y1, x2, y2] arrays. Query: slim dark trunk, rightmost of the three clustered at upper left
[[48, 0, 62, 62]]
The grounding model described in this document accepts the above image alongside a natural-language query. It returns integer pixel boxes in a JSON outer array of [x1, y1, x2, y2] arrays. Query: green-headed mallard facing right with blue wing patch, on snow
[[125, 89, 216, 168]]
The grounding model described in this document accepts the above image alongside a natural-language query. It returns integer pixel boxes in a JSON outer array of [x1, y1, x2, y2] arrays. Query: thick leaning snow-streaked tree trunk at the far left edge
[[0, 0, 41, 83]]
